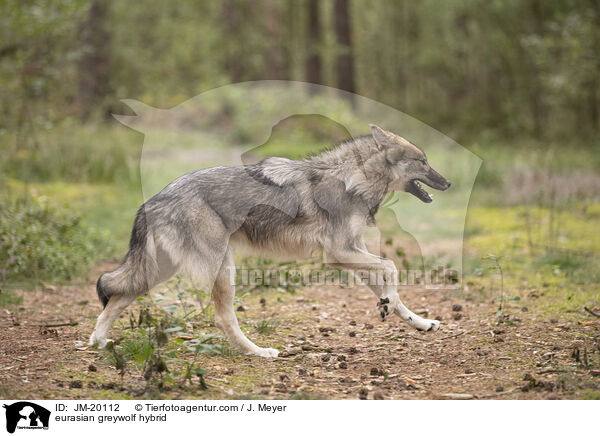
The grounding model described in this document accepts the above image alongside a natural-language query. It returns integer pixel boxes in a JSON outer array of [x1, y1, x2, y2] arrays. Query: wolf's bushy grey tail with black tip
[[96, 206, 156, 307]]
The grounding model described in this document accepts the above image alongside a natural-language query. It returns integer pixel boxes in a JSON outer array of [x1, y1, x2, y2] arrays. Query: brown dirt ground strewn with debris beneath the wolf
[[0, 264, 600, 399]]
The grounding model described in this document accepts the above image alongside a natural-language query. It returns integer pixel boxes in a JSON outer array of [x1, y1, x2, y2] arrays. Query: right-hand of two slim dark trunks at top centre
[[333, 0, 356, 101]]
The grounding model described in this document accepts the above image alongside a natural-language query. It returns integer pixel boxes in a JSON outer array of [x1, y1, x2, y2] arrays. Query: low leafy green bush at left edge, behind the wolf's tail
[[0, 197, 109, 280]]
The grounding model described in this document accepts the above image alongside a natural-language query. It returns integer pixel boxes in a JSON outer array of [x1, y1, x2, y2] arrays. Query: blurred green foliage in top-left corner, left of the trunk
[[0, 0, 87, 129]]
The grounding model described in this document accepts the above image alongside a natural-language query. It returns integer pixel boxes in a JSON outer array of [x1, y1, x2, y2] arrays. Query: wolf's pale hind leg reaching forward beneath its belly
[[212, 248, 279, 357]]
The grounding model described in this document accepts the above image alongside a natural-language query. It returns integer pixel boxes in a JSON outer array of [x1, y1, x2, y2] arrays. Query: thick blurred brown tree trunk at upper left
[[79, 0, 111, 118]]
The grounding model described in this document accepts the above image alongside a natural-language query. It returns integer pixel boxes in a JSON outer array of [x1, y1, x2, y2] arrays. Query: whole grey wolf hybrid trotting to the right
[[90, 125, 450, 357]]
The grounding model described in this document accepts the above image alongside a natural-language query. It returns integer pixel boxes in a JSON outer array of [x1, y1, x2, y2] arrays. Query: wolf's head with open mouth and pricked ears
[[370, 124, 451, 203]]
